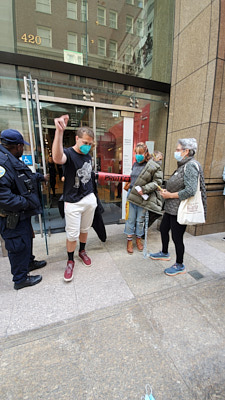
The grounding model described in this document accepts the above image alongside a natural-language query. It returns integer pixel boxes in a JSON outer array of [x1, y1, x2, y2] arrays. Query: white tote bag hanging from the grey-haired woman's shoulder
[[177, 163, 205, 225]]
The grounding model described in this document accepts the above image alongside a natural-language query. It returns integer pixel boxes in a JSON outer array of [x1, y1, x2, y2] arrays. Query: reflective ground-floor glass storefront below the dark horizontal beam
[[0, 65, 168, 229]]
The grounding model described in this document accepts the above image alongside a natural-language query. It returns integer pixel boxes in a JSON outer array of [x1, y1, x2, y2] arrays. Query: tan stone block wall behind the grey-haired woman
[[165, 0, 225, 235]]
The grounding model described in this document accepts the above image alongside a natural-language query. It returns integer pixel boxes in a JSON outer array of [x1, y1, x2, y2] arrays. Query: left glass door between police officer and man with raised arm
[[29, 101, 93, 234]]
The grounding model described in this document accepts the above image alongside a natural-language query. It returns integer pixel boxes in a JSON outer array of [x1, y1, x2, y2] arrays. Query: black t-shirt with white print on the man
[[63, 147, 94, 203]]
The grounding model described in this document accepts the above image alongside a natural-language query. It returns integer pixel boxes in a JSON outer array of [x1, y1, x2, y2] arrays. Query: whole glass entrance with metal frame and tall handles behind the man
[[22, 77, 142, 238]]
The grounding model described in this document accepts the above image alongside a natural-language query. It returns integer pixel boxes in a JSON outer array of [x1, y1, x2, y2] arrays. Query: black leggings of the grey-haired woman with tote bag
[[160, 213, 187, 264]]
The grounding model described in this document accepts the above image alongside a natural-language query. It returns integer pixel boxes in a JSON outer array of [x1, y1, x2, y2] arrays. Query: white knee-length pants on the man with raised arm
[[64, 193, 97, 242]]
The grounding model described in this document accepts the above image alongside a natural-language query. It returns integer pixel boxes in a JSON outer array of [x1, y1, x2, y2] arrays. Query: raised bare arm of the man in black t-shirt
[[52, 115, 69, 165]]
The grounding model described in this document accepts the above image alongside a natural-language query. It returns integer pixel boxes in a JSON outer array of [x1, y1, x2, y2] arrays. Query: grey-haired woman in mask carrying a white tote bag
[[149, 138, 207, 276]]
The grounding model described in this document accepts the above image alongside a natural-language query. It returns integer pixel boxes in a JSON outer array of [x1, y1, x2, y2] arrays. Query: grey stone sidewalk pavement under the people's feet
[[0, 224, 225, 400]]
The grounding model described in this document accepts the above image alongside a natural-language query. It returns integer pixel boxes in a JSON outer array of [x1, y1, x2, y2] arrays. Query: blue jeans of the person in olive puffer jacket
[[124, 202, 146, 237]]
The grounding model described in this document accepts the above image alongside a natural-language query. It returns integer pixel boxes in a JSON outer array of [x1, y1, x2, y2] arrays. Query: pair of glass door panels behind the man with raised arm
[[36, 101, 123, 228]]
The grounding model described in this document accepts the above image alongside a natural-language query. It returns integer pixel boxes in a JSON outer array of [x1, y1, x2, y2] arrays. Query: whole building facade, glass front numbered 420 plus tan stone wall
[[0, 0, 225, 234]]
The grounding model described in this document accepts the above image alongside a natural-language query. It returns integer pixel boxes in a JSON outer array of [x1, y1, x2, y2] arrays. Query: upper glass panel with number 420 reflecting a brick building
[[0, 0, 175, 83]]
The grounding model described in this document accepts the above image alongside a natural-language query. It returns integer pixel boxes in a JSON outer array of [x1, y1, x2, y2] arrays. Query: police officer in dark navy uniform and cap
[[0, 129, 48, 290]]
